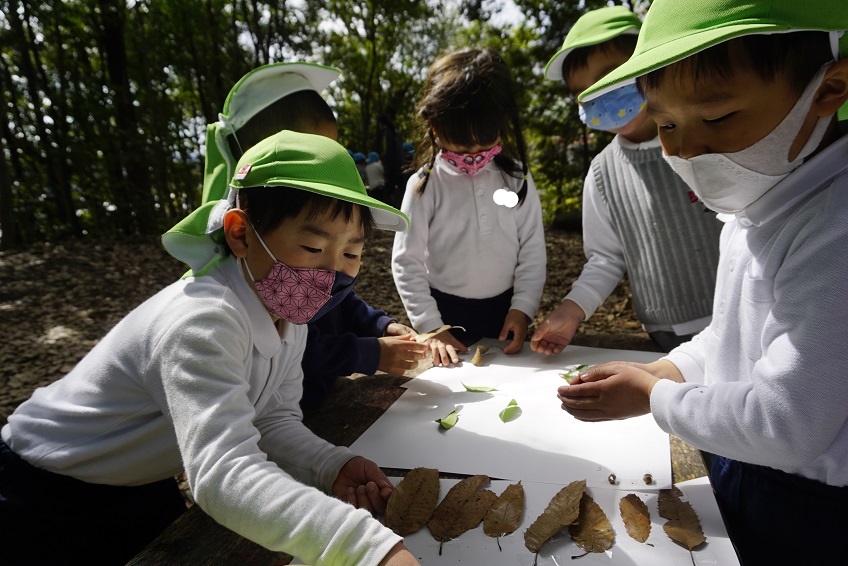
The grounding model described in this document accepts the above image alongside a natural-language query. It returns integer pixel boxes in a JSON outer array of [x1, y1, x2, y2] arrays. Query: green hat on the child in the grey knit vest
[[545, 6, 642, 81]]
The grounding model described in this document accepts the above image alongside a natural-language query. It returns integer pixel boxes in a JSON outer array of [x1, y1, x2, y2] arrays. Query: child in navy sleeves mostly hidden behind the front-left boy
[[203, 63, 426, 410]]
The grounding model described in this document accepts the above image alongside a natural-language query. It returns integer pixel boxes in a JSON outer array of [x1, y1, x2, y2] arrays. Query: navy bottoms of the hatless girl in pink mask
[[430, 287, 512, 346]]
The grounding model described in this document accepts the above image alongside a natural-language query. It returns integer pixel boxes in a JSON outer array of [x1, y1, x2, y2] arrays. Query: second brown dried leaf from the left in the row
[[427, 475, 498, 542]]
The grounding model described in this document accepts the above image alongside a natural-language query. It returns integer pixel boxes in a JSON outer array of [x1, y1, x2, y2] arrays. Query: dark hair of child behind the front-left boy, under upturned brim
[[228, 90, 336, 159]]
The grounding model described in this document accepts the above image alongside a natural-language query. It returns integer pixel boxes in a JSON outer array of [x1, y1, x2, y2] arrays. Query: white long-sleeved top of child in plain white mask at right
[[651, 136, 848, 486]]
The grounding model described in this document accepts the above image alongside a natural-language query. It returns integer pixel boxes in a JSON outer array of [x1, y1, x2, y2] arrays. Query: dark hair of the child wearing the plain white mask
[[636, 31, 833, 93]]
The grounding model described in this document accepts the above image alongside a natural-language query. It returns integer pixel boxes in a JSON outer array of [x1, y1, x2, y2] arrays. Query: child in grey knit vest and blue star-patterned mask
[[530, 6, 721, 354]]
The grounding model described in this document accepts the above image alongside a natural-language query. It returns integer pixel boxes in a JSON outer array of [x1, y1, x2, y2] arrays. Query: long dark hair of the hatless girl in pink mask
[[414, 48, 527, 203]]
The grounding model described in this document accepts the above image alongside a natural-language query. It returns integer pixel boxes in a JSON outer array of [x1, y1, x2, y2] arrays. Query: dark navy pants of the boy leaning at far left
[[0, 440, 186, 566]]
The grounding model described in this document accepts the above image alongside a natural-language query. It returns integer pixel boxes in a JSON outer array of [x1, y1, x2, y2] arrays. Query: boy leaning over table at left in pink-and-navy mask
[[0, 131, 417, 564]]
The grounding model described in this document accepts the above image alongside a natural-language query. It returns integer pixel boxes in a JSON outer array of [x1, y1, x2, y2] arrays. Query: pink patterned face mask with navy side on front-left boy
[[242, 225, 355, 324]]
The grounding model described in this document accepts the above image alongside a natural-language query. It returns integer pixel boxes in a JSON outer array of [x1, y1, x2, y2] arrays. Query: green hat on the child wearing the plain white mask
[[579, 0, 848, 102]]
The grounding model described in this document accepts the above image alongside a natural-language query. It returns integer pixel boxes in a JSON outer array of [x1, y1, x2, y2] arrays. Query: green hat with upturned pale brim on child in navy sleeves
[[203, 63, 340, 202]]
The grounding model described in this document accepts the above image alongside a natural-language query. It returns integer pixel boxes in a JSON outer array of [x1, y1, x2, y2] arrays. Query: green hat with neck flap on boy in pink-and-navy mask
[[162, 130, 409, 274]]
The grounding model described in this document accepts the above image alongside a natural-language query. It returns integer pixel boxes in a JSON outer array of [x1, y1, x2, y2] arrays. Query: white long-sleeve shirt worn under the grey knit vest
[[565, 136, 710, 336]]
